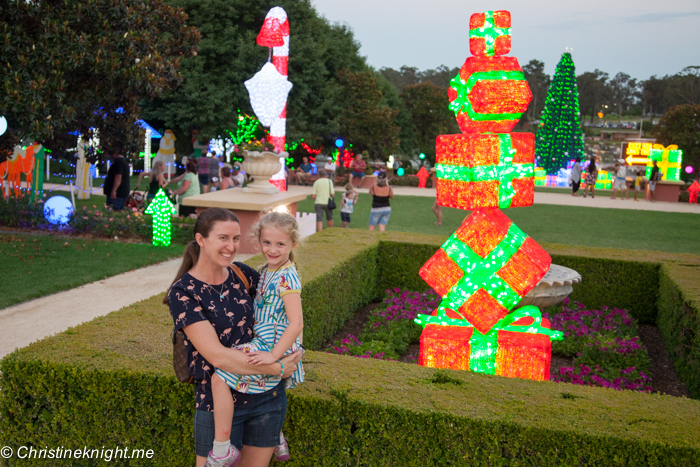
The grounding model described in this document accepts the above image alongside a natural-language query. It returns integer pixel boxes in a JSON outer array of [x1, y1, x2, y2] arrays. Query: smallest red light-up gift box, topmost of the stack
[[469, 10, 510, 57]]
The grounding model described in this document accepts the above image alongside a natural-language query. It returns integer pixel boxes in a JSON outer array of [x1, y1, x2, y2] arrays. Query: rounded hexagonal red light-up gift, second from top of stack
[[447, 57, 532, 133]]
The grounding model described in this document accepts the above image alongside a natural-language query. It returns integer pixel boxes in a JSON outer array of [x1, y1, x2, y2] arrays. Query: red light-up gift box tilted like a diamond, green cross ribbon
[[419, 209, 552, 334]]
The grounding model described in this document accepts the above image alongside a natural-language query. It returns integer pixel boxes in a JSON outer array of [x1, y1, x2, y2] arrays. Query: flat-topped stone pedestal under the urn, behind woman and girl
[[182, 186, 308, 254]]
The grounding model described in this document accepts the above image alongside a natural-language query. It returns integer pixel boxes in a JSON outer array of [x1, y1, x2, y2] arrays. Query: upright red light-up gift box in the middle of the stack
[[435, 133, 535, 211]]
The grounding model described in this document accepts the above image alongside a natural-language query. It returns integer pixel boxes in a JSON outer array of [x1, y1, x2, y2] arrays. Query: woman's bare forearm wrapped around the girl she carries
[[182, 322, 301, 378]]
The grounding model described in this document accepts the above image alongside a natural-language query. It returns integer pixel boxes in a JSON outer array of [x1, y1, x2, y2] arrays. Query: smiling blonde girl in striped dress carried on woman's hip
[[205, 212, 304, 467]]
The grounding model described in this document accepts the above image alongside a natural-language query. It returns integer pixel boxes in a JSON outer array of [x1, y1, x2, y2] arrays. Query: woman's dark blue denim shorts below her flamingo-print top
[[194, 381, 287, 457]]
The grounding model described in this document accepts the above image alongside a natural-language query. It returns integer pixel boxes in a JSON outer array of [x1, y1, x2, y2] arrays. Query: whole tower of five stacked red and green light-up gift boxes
[[416, 11, 562, 380]]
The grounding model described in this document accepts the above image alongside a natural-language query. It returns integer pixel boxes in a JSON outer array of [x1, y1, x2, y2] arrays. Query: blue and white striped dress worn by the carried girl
[[216, 263, 304, 394]]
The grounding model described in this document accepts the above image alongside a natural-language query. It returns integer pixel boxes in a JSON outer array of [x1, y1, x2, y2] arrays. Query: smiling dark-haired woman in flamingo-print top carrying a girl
[[164, 208, 301, 467]]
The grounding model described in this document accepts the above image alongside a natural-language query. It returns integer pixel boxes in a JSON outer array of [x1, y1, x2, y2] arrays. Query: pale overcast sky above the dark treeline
[[312, 0, 700, 79]]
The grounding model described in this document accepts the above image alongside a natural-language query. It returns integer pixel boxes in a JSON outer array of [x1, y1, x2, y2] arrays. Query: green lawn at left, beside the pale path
[[0, 234, 183, 308]]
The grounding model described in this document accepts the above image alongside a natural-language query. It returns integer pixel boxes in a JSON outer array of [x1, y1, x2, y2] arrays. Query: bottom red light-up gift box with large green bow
[[416, 306, 563, 381]]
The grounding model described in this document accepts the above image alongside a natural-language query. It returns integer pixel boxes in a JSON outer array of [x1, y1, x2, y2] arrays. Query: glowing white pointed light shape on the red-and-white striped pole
[[245, 62, 292, 127]]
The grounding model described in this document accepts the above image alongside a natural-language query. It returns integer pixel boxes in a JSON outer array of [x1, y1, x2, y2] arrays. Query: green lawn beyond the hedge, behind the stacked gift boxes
[[298, 193, 700, 254]]
